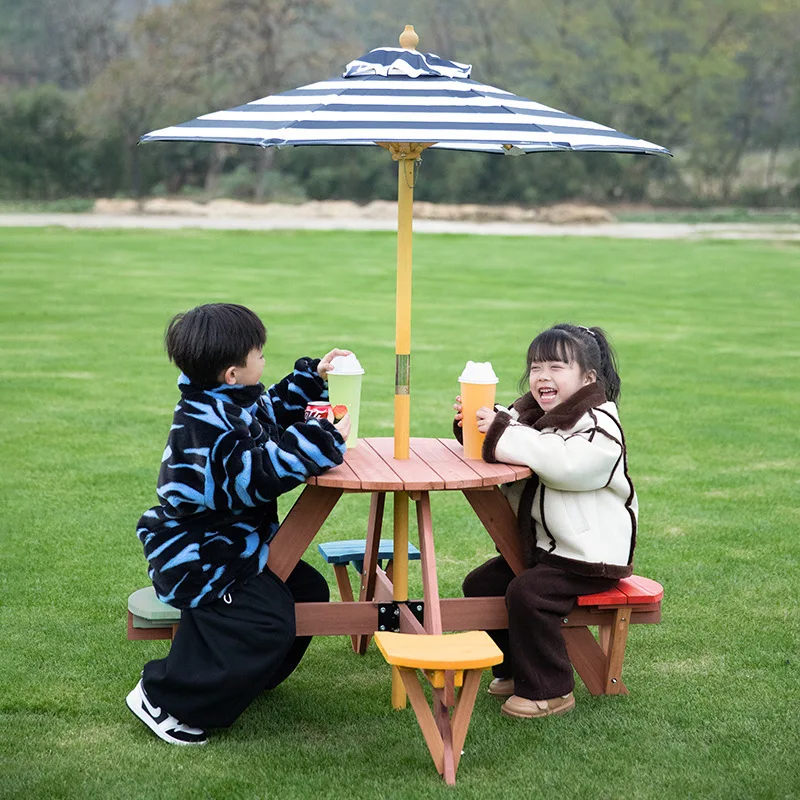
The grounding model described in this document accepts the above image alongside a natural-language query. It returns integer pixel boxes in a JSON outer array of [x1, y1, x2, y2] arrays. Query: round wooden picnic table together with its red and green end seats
[[128, 438, 663, 698]]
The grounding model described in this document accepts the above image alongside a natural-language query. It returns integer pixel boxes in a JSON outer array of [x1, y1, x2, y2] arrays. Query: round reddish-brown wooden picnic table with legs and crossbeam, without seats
[[269, 438, 531, 646]]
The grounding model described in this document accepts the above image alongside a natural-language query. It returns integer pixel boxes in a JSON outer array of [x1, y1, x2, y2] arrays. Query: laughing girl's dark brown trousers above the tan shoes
[[463, 556, 617, 700]]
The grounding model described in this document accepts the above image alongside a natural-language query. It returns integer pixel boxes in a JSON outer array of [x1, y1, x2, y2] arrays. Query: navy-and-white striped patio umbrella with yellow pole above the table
[[141, 25, 670, 459]]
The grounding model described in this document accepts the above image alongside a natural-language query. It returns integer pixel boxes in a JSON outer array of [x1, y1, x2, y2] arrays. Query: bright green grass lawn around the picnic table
[[0, 229, 800, 800]]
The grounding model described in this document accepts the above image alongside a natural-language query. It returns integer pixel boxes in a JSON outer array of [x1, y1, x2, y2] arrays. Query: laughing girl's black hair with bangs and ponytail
[[520, 322, 621, 403]]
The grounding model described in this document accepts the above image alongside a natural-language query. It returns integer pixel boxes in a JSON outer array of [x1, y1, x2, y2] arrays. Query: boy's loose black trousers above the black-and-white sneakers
[[142, 561, 330, 728]]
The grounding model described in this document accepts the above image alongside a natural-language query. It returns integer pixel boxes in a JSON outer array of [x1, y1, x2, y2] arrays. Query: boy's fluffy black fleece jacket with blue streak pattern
[[136, 358, 345, 608]]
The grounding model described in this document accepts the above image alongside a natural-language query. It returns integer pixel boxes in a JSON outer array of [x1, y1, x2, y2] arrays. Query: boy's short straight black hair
[[164, 303, 267, 388]]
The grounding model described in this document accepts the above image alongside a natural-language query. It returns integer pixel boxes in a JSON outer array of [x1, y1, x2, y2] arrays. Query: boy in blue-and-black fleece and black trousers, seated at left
[[126, 303, 350, 745]]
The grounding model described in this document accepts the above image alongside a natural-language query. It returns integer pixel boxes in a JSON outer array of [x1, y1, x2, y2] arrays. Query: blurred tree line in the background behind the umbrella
[[0, 0, 800, 206]]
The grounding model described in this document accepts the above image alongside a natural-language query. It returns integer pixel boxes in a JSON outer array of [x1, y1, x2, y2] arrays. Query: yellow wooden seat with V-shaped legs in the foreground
[[375, 631, 503, 786]]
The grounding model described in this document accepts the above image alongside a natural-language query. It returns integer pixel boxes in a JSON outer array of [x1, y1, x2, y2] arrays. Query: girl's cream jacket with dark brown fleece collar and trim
[[483, 384, 638, 578]]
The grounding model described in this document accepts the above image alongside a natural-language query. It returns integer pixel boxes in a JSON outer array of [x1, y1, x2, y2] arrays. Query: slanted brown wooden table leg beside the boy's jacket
[[268, 484, 342, 581]]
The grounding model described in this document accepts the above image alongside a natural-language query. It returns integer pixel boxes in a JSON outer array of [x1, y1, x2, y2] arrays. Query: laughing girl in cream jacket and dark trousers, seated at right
[[455, 324, 638, 718]]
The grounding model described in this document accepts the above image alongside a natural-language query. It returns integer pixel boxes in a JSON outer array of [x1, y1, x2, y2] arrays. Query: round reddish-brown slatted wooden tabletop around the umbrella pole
[[307, 437, 532, 492]]
